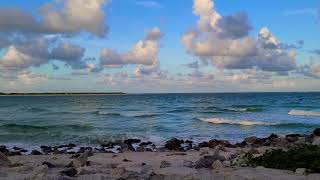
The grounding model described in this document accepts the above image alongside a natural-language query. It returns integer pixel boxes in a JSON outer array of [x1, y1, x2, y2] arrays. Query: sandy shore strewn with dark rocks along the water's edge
[[0, 128, 320, 180]]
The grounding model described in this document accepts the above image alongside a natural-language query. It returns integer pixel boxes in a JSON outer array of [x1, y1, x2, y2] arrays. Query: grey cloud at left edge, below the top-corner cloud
[[0, 37, 88, 71]]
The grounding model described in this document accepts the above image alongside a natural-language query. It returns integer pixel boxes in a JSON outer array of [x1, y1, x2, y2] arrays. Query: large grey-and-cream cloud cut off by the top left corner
[[0, 0, 108, 36]]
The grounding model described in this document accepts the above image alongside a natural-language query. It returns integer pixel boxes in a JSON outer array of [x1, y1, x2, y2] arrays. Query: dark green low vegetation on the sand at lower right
[[246, 145, 320, 173]]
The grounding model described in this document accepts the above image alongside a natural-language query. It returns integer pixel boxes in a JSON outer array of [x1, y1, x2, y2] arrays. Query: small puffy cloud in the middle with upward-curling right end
[[100, 28, 163, 67]]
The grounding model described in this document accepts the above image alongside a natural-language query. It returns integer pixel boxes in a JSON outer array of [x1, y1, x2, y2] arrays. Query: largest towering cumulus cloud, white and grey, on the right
[[182, 0, 303, 73]]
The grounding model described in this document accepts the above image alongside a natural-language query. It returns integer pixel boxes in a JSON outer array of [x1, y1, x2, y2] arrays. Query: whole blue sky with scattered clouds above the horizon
[[0, 0, 320, 93]]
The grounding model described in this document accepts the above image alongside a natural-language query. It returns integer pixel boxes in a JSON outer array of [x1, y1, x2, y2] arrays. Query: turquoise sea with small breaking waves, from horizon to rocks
[[0, 93, 320, 146]]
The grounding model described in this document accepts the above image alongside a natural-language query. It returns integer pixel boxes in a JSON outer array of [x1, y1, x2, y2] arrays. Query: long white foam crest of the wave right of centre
[[200, 118, 277, 126]]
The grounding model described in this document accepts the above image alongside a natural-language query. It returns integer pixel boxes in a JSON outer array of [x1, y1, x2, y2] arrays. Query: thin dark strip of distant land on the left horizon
[[0, 92, 126, 96]]
